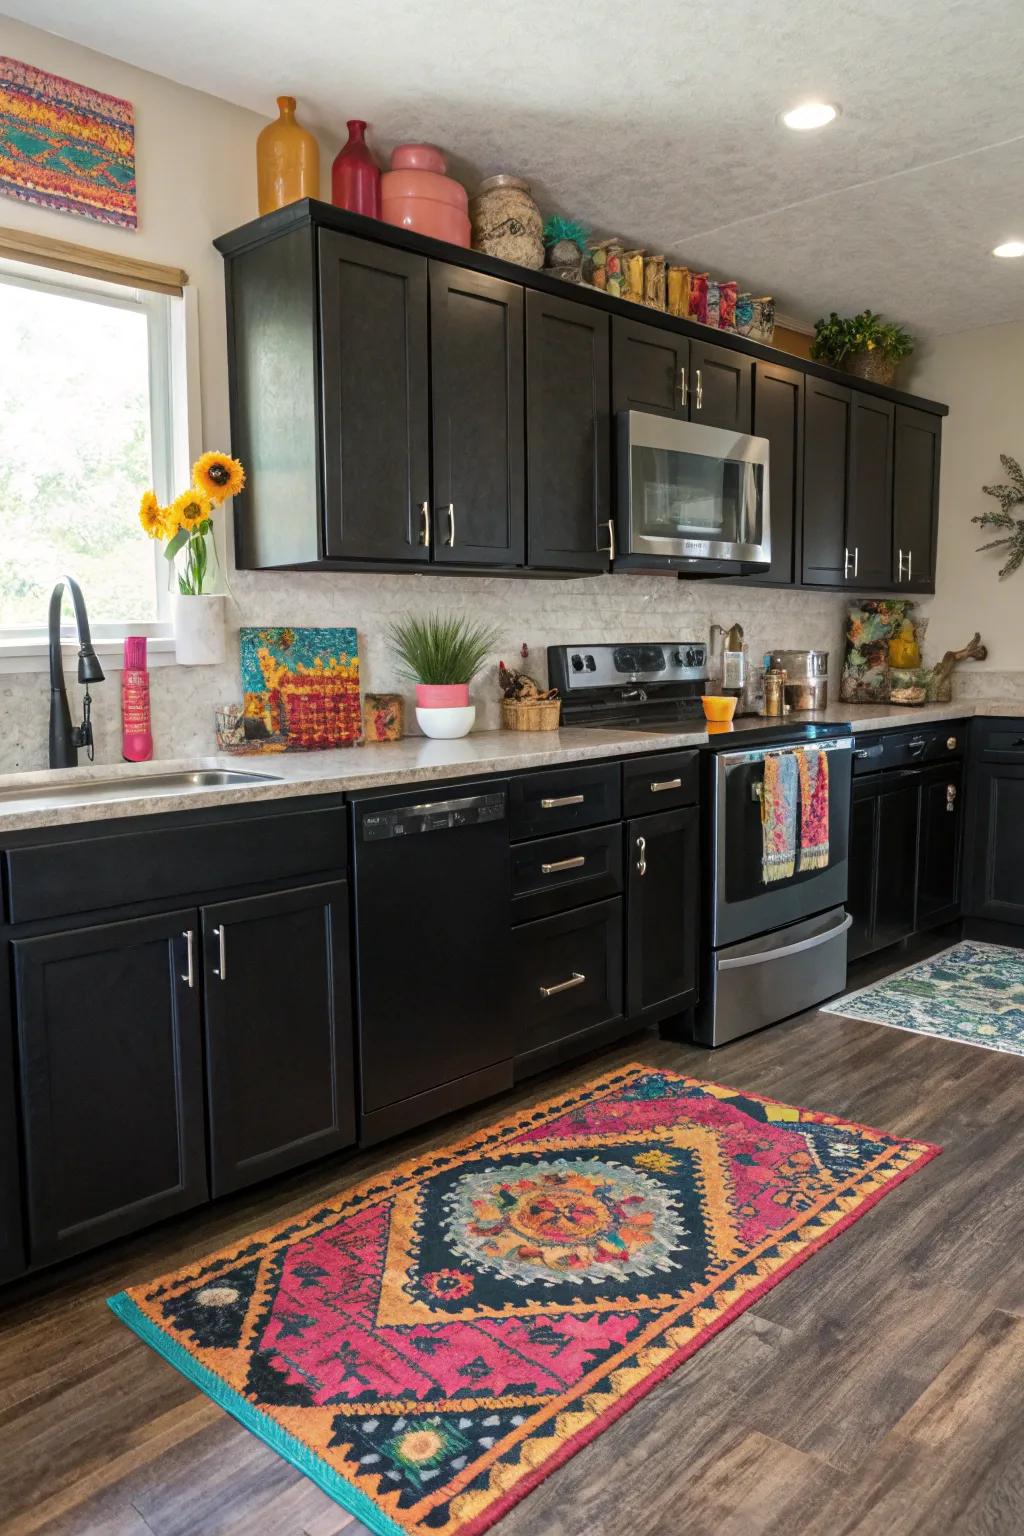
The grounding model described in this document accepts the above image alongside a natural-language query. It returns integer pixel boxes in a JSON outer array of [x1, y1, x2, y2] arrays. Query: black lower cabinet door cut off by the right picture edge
[[970, 762, 1024, 923]]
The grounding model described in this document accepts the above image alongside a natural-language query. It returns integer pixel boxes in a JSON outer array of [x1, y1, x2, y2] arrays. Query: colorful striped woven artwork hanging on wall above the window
[[0, 57, 138, 229]]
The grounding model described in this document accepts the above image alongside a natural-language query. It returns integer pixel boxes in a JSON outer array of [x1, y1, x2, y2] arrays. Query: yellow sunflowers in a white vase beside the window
[[138, 453, 246, 665]]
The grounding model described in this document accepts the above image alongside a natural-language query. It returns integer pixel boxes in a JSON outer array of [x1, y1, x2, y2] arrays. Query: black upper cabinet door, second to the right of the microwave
[[801, 375, 854, 587]]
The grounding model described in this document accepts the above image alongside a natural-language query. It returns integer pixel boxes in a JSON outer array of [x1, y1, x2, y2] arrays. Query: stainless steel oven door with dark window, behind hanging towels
[[711, 737, 852, 949]]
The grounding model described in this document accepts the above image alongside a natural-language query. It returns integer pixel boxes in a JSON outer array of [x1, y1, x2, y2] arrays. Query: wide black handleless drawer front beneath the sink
[[3, 808, 347, 923]]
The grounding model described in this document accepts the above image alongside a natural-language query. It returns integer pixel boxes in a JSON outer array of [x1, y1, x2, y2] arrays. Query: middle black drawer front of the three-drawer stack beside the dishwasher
[[511, 822, 622, 923]]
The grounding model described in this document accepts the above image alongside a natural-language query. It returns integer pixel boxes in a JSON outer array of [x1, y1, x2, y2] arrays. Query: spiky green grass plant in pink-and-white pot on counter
[[388, 613, 497, 740]]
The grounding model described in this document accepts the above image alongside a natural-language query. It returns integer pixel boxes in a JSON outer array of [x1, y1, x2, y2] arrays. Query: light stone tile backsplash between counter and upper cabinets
[[0, 571, 847, 773]]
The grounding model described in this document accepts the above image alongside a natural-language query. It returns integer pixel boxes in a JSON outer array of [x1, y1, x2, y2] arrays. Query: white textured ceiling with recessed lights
[[8, 0, 1024, 336]]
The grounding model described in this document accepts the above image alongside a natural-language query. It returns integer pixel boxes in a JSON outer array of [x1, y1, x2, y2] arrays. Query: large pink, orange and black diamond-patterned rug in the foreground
[[111, 1066, 940, 1536]]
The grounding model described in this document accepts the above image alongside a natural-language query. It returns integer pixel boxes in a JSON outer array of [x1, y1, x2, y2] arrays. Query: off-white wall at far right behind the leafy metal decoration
[[913, 324, 1024, 678]]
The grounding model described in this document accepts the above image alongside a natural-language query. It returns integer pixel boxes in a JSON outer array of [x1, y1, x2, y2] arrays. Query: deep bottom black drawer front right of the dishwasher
[[513, 897, 623, 1055]]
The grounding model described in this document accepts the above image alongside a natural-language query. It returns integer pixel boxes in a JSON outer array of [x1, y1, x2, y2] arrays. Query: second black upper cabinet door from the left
[[430, 261, 527, 565]]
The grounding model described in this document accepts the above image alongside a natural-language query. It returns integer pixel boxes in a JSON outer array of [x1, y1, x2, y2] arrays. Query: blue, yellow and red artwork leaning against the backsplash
[[239, 628, 362, 753]]
